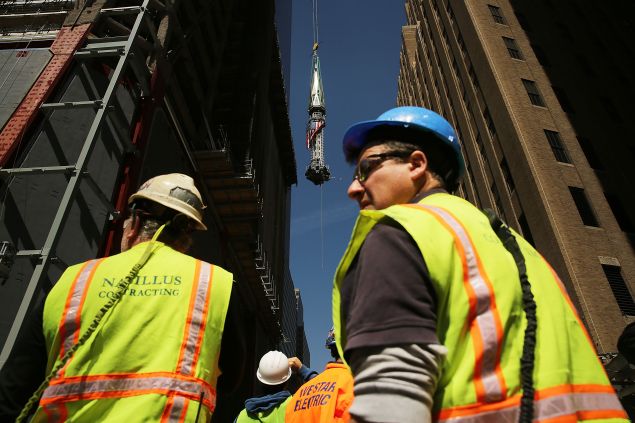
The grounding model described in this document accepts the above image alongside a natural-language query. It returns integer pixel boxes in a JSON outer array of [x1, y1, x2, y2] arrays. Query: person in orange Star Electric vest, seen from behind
[[285, 329, 353, 423]]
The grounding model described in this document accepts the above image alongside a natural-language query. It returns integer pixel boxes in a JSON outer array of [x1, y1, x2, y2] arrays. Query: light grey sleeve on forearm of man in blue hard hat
[[349, 344, 447, 423]]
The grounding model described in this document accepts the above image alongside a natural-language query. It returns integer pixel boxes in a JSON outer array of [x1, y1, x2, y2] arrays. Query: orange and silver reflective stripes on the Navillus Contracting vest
[[41, 259, 216, 421]]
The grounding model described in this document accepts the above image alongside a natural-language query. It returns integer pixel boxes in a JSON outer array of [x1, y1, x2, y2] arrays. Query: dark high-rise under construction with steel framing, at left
[[0, 0, 304, 421]]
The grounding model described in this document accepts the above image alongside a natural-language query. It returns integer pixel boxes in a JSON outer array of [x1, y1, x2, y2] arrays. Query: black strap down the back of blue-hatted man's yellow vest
[[483, 209, 538, 423]]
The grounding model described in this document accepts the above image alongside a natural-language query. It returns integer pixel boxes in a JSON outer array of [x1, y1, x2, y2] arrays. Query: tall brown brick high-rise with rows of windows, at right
[[398, 0, 635, 360]]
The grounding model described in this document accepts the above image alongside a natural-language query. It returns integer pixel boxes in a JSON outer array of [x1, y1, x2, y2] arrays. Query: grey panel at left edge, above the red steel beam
[[0, 48, 52, 128]]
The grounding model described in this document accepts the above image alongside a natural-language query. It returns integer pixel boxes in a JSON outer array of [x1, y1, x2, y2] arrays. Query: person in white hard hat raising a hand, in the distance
[[234, 351, 317, 423]]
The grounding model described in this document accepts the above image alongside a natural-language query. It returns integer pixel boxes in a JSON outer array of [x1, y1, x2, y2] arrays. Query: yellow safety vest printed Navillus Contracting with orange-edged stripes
[[33, 242, 232, 423]]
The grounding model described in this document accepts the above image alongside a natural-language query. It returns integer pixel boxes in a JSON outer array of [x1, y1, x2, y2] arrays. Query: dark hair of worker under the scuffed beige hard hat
[[131, 201, 196, 249]]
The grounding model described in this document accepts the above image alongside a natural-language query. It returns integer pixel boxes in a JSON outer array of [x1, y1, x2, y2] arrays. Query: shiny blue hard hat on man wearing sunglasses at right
[[342, 106, 465, 190]]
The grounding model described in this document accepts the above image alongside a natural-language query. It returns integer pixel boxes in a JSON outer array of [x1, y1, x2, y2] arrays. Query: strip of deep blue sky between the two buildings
[[289, 0, 405, 369]]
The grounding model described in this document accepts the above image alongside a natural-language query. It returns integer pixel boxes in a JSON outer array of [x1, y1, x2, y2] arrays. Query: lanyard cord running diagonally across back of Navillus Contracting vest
[[16, 224, 166, 423]]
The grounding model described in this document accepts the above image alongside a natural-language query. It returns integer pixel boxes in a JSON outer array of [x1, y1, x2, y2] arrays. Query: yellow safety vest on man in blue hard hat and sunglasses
[[333, 193, 628, 423]]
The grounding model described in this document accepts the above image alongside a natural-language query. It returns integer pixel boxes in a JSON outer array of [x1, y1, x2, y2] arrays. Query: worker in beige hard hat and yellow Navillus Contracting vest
[[3, 173, 232, 422]]
